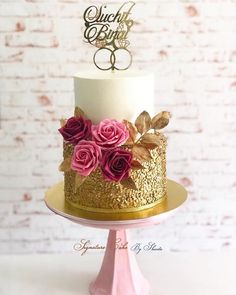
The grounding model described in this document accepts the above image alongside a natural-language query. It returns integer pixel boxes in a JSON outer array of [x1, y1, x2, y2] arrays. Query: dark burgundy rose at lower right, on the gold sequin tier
[[101, 148, 133, 182]]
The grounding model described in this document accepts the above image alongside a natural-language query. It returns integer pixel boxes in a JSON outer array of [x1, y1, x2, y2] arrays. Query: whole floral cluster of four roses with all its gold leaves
[[59, 107, 170, 189]]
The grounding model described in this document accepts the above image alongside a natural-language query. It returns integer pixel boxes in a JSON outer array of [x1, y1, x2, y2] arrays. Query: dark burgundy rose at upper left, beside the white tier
[[58, 117, 92, 145]]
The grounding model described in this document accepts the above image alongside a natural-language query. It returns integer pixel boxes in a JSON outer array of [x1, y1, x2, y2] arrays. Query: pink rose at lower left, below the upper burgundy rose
[[71, 140, 102, 176]]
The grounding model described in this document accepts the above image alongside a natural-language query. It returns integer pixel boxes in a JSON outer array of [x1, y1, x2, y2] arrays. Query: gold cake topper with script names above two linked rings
[[84, 1, 135, 71]]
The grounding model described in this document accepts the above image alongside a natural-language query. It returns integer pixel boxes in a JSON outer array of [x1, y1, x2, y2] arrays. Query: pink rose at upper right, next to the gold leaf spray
[[92, 119, 129, 149]]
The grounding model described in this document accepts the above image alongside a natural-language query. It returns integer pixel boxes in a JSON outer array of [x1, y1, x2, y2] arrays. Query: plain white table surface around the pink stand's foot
[[0, 252, 236, 295]]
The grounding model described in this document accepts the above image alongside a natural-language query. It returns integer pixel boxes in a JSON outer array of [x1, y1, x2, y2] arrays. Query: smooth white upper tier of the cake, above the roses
[[74, 71, 154, 123]]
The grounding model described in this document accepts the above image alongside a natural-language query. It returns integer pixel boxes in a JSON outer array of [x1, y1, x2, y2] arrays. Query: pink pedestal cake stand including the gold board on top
[[45, 180, 187, 295]]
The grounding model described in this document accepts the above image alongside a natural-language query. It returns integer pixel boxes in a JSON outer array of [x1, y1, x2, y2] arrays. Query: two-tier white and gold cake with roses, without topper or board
[[59, 71, 170, 214]]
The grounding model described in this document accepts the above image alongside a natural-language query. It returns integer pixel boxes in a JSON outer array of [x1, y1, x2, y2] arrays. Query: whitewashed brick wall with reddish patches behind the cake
[[0, 0, 236, 253]]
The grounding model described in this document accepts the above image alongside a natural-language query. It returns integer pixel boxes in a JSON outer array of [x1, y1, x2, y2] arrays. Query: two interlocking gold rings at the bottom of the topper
[[93, 47, 132, 71]]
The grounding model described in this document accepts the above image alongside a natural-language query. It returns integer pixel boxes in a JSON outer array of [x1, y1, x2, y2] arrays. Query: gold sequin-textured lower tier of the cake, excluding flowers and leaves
[[63, 134, 167, 213]]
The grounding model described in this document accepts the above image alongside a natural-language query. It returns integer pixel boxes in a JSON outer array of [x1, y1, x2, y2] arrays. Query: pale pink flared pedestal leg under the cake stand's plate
[[89, 230, 149, 295]]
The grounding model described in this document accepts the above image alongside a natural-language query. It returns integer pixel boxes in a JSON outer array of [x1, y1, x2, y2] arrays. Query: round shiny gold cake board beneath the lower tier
[[45, 179, 187, 221]]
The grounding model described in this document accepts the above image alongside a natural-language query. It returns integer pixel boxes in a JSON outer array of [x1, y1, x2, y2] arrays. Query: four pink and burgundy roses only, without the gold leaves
[[59, 116, 132, 182]]
